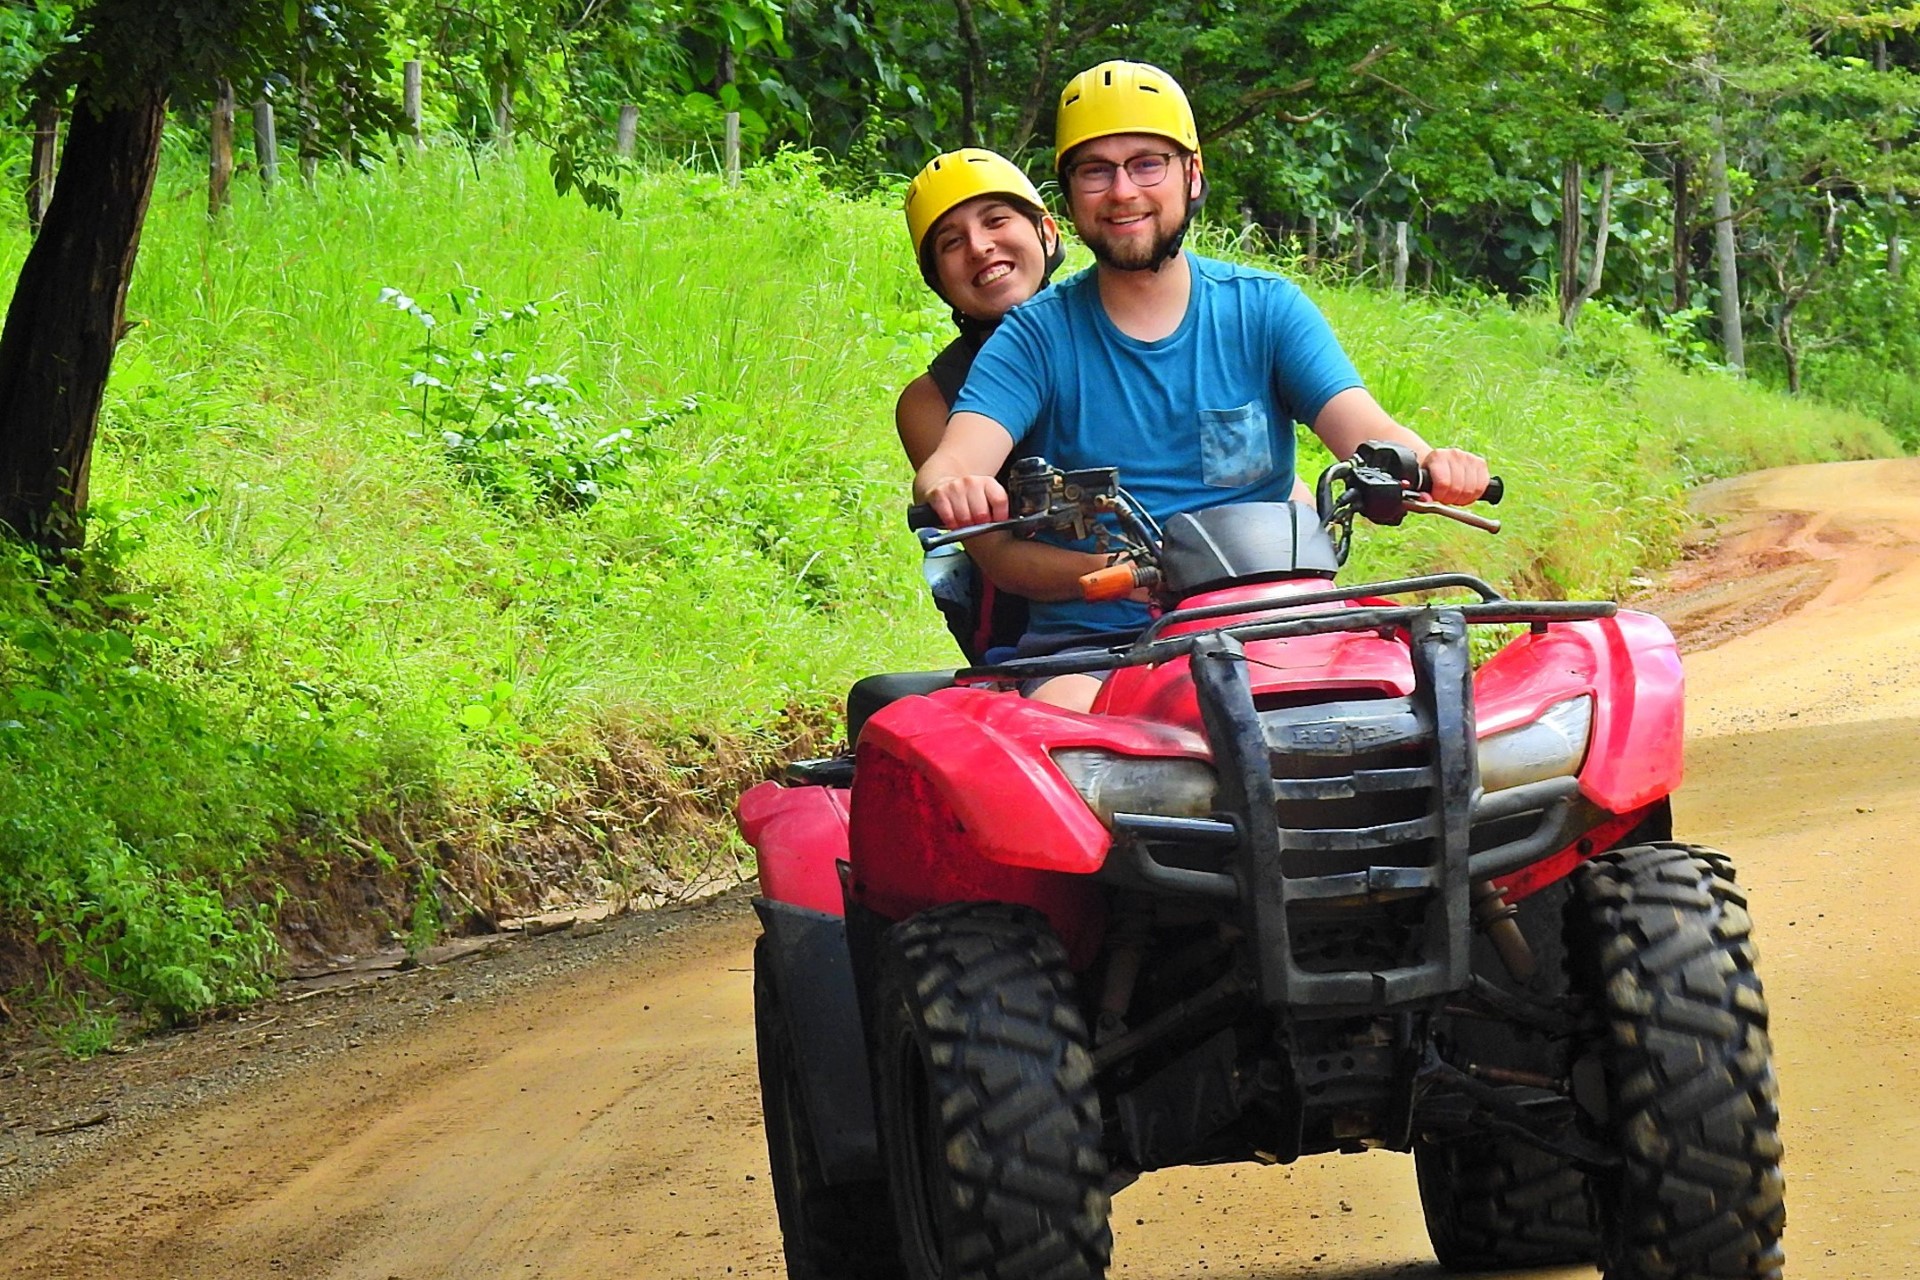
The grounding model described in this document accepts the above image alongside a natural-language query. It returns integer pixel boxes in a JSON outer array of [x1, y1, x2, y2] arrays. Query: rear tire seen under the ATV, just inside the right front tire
[[1413, 1134, 1599, 1270]]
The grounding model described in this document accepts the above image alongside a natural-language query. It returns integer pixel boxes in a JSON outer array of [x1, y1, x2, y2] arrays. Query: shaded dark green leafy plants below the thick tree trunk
[[0, 537, 273, 1019]]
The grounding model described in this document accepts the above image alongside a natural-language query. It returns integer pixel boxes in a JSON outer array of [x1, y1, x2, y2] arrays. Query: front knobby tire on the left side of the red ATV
[[876, 904, 1114, 1280]]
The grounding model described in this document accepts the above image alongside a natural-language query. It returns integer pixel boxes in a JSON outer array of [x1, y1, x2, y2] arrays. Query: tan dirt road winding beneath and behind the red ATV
[[0, 461, 1920, 1280]]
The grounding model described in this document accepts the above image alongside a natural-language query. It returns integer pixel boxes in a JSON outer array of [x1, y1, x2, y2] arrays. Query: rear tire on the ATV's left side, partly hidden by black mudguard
[[753, 938, 900, 1280]]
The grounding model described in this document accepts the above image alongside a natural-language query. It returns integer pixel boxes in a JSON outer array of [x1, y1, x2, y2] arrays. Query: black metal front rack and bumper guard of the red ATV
[[962, 574, 1615, 1017]]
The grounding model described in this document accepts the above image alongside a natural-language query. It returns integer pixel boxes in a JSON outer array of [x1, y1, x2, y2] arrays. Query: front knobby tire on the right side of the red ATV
[[1569, 842, 1786, 1280]]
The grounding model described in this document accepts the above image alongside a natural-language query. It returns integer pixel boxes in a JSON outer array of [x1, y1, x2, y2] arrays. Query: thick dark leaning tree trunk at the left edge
[[0, 88, 167, 553]]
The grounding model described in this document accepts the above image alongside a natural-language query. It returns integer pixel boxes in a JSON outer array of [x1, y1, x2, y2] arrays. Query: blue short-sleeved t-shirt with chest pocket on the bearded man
[[954, 253, 1361, 635]]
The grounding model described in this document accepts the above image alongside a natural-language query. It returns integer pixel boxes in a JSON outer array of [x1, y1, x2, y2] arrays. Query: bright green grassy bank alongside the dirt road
[[0, 142, 1891, 1017]]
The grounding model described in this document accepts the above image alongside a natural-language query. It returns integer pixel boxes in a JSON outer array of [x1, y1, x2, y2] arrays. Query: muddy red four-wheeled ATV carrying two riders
[[739, 445, 1786, 1280]]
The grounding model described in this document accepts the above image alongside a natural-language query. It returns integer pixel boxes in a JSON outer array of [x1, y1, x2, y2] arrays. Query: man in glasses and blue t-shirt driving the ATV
[[914, 61, 1488, 710]]
